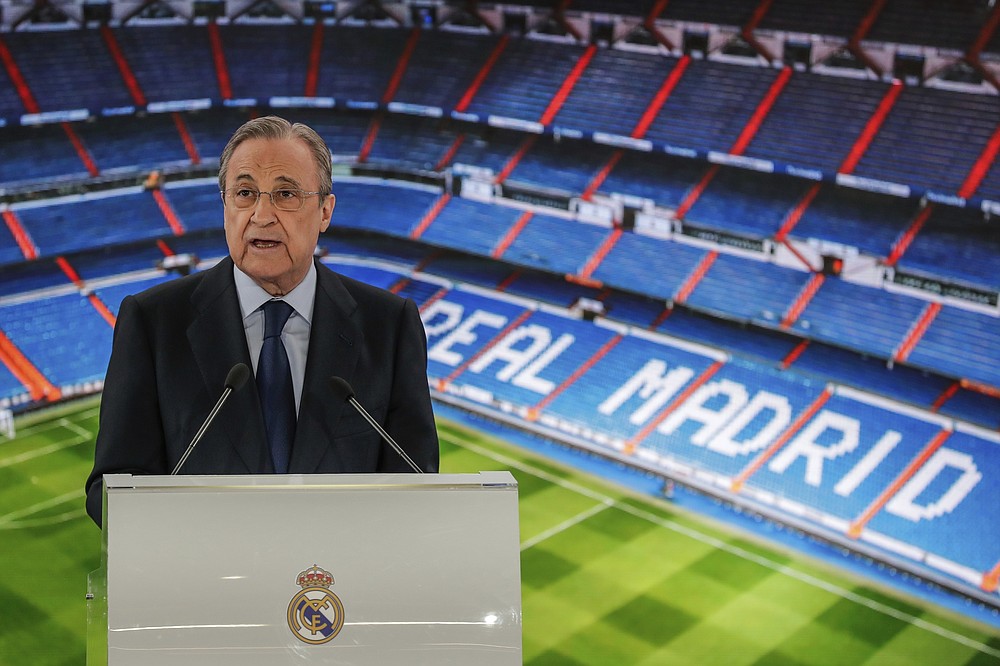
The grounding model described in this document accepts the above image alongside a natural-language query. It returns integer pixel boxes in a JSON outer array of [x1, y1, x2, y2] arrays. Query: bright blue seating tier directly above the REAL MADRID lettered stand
[[1, 177, 1000, 404]]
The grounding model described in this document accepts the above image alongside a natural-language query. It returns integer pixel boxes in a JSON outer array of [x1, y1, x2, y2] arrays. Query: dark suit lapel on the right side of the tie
[[289, 261, 364, 474]]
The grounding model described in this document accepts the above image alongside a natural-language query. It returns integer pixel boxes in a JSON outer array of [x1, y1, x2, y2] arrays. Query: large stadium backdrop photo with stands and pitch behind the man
[[0, 0, 1000, 665]]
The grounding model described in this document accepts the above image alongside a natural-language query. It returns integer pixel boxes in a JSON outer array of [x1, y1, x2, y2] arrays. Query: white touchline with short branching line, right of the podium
[[441, 435, 1000, 658]]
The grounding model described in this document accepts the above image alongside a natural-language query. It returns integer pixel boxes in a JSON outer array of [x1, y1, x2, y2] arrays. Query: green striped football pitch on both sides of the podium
[[0, 400, 1000, 666]]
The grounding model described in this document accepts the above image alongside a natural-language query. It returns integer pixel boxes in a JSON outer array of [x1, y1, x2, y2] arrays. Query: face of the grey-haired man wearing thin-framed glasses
[[224, 139, 336, 296]]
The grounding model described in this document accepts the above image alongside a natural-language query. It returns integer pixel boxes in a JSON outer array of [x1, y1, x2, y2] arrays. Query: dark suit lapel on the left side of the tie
[[187, 257, 273, 474]]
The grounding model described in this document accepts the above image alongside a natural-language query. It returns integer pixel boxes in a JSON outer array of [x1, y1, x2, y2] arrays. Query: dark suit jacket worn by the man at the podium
[[87, 257, 438, 525]]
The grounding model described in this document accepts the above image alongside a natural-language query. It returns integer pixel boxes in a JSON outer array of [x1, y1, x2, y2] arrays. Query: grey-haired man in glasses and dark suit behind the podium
[[87, 116, 438, 525]]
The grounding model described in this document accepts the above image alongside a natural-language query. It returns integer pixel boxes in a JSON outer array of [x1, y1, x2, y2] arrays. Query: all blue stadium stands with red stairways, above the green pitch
[[0, 6, 1000, 605]]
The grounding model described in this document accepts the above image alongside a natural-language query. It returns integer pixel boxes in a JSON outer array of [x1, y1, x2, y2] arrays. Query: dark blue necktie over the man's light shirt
[[257, 301, 296, 474]]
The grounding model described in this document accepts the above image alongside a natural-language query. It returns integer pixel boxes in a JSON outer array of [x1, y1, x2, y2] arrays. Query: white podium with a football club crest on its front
[[87, 472, 521, 666]]
